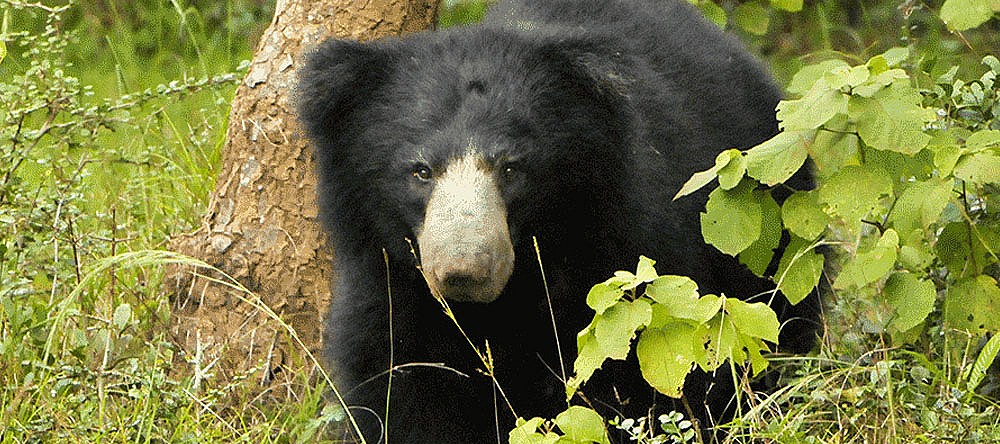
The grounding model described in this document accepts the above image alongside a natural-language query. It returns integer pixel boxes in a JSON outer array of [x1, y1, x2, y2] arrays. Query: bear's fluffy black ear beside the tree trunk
[[296, 39, 395, 141]]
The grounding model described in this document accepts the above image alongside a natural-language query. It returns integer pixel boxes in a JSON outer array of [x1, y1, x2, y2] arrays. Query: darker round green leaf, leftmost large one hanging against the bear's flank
[[701, 180, 762, 256]]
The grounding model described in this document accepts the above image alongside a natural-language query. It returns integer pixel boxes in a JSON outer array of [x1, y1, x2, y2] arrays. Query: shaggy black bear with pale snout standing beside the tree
[[298, 0, 812, 443]]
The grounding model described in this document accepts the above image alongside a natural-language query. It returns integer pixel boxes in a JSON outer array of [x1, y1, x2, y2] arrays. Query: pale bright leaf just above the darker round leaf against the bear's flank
[[747, 131, 816, 186]]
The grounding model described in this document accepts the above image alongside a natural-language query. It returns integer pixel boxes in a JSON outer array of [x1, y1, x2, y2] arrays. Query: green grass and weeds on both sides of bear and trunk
[[0, 0, 1000, 443]]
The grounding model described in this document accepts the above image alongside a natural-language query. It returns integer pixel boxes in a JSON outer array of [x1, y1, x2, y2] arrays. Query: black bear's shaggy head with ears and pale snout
[[298, 29, 630, 303]]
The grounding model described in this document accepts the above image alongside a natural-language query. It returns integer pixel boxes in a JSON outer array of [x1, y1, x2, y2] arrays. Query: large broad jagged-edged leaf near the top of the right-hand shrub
[[848, 80, 934, 155]]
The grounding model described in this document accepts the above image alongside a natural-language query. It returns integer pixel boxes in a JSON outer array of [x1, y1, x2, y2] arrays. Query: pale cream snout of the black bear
[[417, 156, 514, 303]]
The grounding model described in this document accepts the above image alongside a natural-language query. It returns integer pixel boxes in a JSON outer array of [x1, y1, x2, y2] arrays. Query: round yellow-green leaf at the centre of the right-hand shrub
[[819, 166, 892, 223]]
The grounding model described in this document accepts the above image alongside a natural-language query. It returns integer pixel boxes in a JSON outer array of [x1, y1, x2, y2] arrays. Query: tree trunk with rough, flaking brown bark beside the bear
[[167, 0, 438, 379]]
